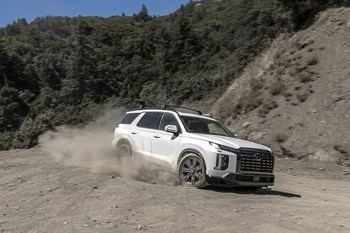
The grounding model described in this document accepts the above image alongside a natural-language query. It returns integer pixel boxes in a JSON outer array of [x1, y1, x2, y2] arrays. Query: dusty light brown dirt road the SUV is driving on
[[0, 147, 350, 233]]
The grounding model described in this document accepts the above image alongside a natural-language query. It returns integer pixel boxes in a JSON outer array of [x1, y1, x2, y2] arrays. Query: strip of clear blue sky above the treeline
[[0, 0, 190, 27]]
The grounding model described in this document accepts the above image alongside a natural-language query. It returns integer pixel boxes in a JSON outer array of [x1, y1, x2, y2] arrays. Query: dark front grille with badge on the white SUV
[[237, 148, 274, 173]]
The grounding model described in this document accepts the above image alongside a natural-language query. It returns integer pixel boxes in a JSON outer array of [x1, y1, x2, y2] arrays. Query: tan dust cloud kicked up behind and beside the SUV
[[39, 109, 178, 185]]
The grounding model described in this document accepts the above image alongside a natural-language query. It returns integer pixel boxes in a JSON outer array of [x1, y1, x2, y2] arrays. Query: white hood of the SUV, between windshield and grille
[[190, 133, 271, 152]]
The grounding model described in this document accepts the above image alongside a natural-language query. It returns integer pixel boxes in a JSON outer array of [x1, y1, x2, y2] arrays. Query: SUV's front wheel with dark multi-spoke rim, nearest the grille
[[178, 153, 208, 188]]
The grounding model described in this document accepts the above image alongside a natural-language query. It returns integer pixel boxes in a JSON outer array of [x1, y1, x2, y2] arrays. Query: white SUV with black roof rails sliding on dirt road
[[112, 105, 275, 188]]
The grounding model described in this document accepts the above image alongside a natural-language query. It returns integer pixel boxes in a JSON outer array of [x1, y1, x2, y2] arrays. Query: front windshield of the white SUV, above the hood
[[180, 116, 235, 137]]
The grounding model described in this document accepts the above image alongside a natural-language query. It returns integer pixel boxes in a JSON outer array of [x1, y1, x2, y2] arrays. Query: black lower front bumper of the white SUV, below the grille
[[207, 173, 275, 187]]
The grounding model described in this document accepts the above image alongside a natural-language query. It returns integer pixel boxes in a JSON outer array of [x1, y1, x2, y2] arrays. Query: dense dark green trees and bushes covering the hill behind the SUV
[[0, 0, 347, 149]]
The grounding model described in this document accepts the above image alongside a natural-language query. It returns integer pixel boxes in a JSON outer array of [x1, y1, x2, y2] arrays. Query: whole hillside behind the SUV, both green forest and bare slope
[[0, 0, 350, 158]]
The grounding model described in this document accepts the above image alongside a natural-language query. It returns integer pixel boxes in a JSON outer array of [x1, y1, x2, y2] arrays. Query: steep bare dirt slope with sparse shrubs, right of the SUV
[[211, 8, 350, 165]]
